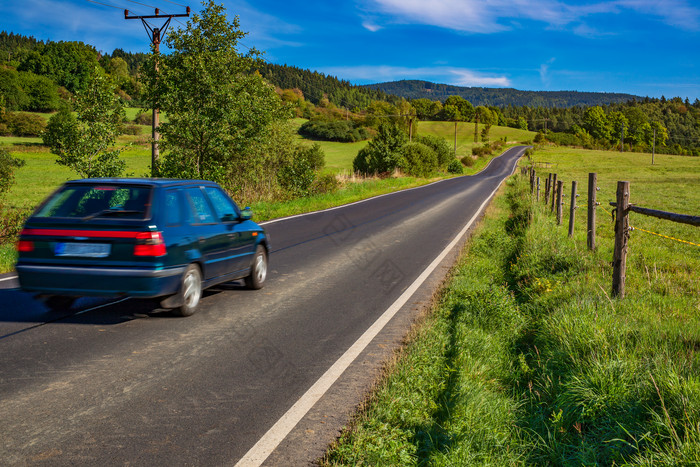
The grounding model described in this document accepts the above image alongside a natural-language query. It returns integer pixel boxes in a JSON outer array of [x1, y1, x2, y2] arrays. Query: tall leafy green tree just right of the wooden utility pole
[[144, 1, 291, 186]]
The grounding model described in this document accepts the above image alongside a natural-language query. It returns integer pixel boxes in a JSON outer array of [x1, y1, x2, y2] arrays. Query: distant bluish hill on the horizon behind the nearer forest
[[364, 80, 643, 108]]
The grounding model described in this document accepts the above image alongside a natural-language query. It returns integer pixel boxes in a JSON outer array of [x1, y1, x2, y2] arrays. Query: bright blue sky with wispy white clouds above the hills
[[0, 0, 700, 101]]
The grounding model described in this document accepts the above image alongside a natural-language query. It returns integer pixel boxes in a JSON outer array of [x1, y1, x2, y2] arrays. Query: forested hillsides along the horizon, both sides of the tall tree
[[0, 32, 700, 155]]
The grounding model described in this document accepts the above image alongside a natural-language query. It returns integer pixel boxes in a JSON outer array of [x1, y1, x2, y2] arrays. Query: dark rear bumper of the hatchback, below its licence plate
[[16, 264, 185, 298]]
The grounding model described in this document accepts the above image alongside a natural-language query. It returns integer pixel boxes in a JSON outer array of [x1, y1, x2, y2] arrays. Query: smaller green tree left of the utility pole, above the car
[[43, 66, 126, 178]]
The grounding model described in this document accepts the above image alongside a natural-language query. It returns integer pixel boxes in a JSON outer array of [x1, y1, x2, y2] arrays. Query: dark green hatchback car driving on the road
[[16, 178, 270, 316]]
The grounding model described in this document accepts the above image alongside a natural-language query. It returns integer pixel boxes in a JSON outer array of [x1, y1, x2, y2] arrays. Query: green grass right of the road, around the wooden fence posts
[[322, 152, 700, 466]]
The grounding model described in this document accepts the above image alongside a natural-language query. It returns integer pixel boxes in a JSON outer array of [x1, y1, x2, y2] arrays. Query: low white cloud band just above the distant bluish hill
[[318, 65, 511, 87]]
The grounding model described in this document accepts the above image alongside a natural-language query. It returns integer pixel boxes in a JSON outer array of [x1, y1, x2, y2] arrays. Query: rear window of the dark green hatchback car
[[35, 184, 152, 219]]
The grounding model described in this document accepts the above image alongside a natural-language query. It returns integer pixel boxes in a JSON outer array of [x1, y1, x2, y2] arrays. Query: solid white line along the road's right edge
[[236, 149, 520, 467]]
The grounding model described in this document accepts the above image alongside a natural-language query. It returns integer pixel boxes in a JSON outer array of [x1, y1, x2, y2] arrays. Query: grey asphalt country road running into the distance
[[0, 147, 525, 466]]
